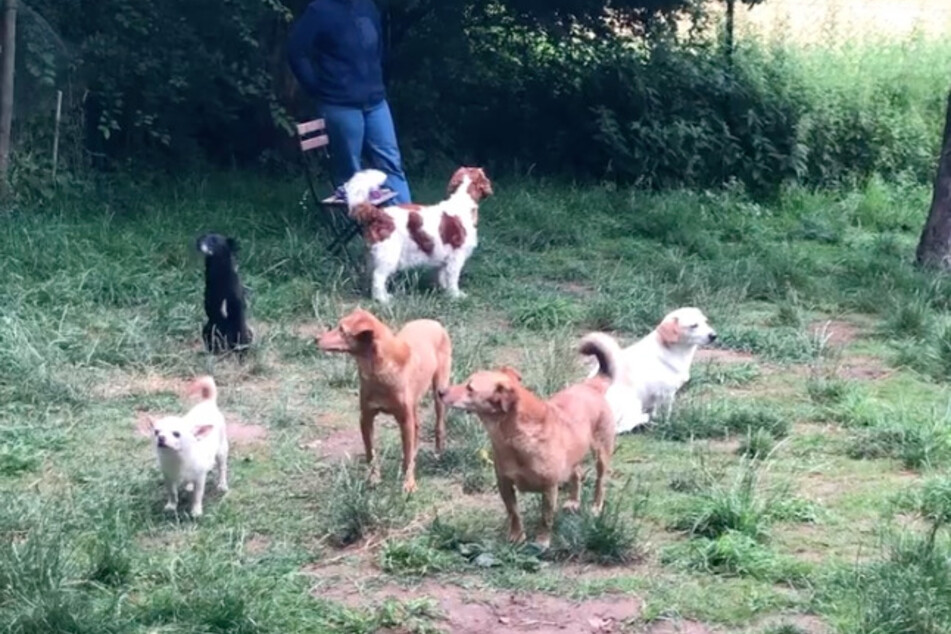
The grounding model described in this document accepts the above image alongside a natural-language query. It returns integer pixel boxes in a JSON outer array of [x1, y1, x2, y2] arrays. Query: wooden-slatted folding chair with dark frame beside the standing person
[[297, 119, 396, 267]]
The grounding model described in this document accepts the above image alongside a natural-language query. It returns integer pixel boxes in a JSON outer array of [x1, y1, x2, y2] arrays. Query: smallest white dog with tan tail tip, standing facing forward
[[149, 376, 228, 517]]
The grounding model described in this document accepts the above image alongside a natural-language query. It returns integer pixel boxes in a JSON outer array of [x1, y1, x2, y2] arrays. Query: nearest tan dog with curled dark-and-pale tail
[[440, 333, 617, 548]]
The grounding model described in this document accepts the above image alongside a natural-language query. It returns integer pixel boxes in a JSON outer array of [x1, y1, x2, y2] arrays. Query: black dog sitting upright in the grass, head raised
[[197, 233, 254, 352]]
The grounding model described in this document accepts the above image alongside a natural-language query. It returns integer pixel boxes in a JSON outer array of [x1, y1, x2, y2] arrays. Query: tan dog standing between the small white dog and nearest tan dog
[[317, 308, 452, 493]]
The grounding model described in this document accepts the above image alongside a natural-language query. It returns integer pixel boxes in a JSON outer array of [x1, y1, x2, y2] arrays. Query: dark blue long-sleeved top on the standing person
[[287, 0, 386, 107]]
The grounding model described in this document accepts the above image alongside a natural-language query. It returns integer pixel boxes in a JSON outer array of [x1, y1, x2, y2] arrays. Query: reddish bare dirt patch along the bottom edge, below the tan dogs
[[312, 580, 642, 634]]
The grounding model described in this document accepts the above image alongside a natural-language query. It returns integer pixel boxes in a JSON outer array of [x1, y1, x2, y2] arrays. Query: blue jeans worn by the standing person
[[322, 100, 412, 204]]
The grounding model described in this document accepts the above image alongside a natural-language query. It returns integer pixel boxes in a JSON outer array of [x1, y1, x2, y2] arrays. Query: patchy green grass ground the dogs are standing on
[[0, 165, 951, 634]]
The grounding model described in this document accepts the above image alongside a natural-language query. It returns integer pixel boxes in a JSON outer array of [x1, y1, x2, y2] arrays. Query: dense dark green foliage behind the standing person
[[13, 0, 948, 191]]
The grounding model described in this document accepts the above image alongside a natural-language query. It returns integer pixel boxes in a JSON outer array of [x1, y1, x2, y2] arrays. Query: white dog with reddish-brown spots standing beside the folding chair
[[350, 167, 492, 303]]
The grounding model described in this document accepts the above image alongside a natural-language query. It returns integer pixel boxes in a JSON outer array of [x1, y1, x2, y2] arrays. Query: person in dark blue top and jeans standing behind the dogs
[[287, 0, 412, 203]]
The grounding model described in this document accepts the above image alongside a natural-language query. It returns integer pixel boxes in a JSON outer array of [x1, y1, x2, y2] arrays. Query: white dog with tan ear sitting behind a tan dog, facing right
[[591, 308, 717, 434]]
